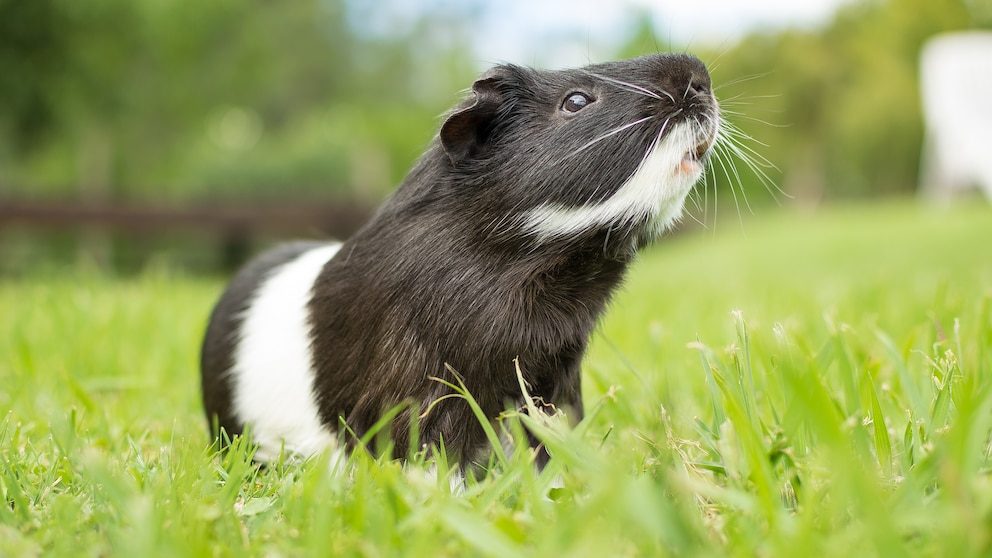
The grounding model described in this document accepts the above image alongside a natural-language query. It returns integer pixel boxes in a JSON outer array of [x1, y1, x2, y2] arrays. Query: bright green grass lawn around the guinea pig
[[0, 205, 992, 557]]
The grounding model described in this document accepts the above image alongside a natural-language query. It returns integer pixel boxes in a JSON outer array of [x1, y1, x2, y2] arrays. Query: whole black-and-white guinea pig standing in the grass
[[201, 54, 721, 466]]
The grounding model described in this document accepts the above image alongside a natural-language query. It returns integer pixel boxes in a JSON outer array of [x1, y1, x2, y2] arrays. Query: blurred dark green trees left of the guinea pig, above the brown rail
[[0, 0, 480, 206]]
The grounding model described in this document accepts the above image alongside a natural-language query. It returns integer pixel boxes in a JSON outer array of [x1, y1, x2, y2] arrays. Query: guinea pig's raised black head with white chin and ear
[[440, 54, 720, 247]]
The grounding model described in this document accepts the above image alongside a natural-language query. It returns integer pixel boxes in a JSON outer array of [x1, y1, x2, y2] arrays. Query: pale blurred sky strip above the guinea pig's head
[[349, 0, 852, 69]]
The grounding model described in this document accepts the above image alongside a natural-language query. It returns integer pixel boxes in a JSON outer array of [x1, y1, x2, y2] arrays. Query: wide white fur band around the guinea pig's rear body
[[230, 243, 341, 460]]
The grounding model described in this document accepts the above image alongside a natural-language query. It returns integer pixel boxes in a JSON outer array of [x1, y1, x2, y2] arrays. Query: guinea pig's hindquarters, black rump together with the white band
[[200, 242, 341, 460]]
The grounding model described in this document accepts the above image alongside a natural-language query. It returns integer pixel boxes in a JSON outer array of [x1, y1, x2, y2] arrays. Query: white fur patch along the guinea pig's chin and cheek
[[523, 123, 703, 241]]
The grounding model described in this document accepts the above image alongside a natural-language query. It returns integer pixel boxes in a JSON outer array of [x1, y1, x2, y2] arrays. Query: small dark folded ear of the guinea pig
[[440, 66, 507, 164]]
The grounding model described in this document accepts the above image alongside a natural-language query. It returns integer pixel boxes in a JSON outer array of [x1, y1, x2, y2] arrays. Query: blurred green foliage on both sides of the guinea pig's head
[[0, 0, 992, 208]]
